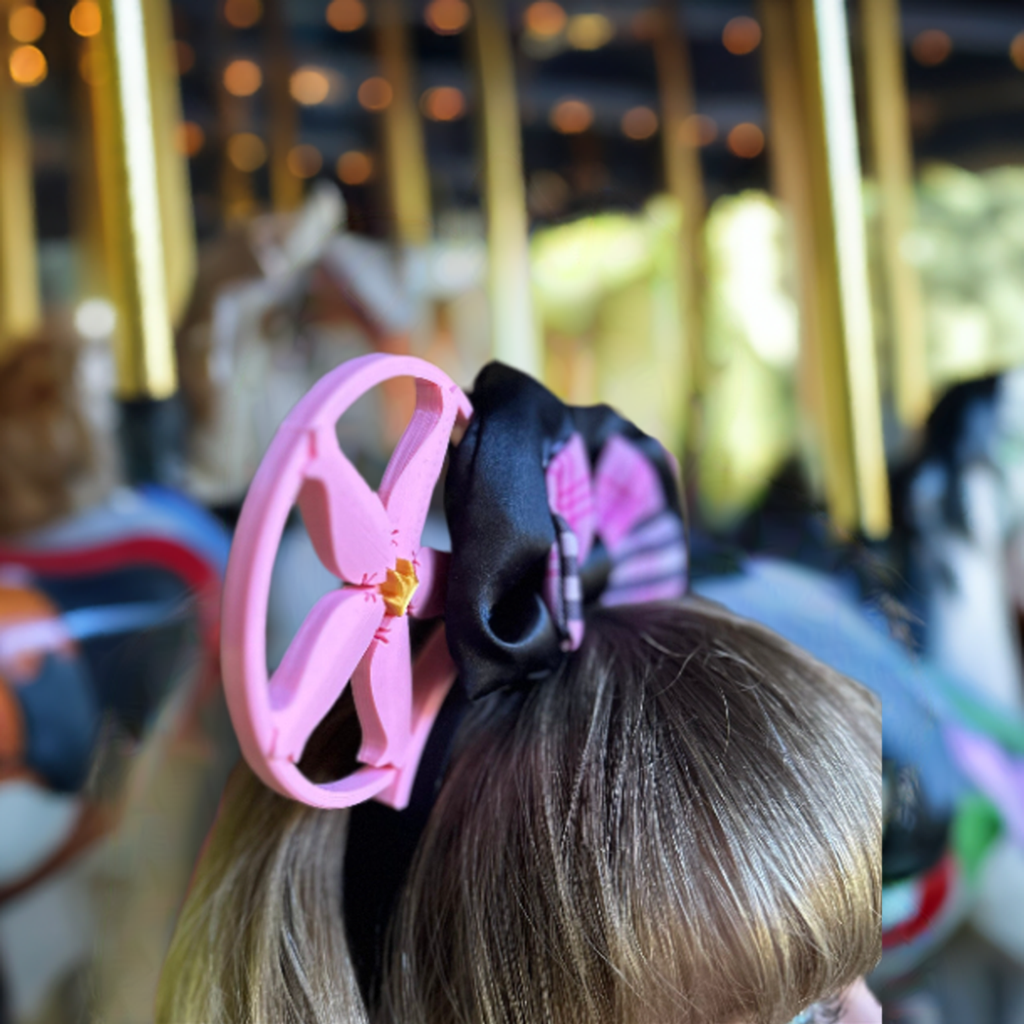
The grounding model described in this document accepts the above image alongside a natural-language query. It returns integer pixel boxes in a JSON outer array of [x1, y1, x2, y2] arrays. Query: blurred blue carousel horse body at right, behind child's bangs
[[693, 542, 1024, 1024]]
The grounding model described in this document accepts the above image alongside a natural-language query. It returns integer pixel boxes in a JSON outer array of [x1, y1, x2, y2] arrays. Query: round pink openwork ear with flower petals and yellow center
[[221, 354, 472, 809]]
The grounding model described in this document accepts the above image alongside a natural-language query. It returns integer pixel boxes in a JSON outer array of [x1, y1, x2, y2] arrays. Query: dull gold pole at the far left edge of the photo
[[0, 0, 42, 354]]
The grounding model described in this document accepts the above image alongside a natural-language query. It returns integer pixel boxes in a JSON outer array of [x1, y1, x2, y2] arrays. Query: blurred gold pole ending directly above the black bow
[[470, 0, 543, 377]]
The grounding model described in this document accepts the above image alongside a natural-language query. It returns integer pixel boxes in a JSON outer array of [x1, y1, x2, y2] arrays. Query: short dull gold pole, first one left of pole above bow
[[374, 0, 431, 246]]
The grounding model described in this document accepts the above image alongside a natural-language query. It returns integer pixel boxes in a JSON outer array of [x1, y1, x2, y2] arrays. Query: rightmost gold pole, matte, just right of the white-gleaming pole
[[860, 0, 932, 429]]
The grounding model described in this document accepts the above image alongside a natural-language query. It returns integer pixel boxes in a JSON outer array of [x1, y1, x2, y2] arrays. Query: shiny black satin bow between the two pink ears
[[444, 362, 682, 699]]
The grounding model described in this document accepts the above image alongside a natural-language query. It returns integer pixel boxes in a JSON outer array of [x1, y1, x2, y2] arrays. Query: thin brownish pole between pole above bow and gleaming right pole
[[652, 0, 707, 400]]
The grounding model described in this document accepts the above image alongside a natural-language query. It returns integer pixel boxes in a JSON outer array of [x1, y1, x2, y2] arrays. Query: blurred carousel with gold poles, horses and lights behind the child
[[0, 0, 1024, 1024]]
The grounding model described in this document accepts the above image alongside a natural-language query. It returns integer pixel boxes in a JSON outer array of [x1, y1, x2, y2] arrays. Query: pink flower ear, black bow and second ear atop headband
[[221, 354, 686, 809]]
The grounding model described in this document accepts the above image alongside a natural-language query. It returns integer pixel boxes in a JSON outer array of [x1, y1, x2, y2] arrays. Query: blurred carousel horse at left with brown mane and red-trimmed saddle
[[0, 339, 229, 1016]]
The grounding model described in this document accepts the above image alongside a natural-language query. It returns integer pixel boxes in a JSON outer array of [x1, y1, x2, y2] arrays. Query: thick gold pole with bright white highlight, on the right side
[[761, 0, 890, 538]]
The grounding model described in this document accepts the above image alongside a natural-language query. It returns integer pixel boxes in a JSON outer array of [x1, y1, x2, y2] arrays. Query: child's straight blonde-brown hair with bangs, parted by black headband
[[158, 598, 882, 1024]]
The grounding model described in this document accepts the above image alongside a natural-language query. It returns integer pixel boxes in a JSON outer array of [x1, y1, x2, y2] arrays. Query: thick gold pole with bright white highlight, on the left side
[[92, 0, 177, 399]]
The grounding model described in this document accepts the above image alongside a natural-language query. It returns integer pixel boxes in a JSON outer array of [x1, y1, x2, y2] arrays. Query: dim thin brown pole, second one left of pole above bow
[[263, 0, 302, 213]]
